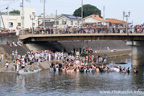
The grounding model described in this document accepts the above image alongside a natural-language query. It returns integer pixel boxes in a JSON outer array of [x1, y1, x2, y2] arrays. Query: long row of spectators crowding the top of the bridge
[[18, 24, 144, 34]]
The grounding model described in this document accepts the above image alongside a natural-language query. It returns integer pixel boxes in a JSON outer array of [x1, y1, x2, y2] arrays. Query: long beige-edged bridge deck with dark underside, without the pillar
[[19, 33, 144, 41]]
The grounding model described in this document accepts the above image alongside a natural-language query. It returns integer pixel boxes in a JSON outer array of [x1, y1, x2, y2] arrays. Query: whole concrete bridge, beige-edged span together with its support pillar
[[19, 33, 144, 65]]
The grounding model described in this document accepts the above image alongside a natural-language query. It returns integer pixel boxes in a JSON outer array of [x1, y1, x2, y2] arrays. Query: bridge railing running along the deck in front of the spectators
[[20, 27, 141, 35]]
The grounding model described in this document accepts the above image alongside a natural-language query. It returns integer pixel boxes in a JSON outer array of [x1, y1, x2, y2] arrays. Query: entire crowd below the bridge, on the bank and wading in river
[[0, 50, 138, 74]]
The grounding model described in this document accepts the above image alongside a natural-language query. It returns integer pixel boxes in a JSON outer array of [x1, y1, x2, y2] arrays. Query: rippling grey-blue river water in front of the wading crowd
[[0, 59, 144, 96]]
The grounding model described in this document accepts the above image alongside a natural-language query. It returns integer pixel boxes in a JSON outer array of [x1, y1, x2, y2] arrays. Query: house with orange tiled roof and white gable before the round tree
[[83, 14, 108, 25]]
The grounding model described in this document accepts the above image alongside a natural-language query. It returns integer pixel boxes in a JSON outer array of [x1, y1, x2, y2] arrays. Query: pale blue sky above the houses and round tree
[[0, 0, 144, 25]]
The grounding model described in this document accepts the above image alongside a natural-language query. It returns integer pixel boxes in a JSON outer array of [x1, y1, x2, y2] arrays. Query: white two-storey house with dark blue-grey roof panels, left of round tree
[[54, 14, 81, 28]]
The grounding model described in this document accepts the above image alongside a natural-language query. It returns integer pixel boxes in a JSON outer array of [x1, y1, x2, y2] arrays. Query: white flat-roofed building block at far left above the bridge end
[[0, 8, 38, 30]]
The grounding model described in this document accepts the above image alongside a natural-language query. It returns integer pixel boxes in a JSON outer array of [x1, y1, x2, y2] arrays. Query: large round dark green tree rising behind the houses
[[73, 4, 102, 17]]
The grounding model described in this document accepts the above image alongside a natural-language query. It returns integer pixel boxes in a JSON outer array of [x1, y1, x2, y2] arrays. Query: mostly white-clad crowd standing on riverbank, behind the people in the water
[[1, 47, 107, 71]]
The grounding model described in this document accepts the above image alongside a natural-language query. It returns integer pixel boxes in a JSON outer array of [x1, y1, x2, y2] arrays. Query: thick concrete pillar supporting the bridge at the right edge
[[127, 41, 144, 66]]
